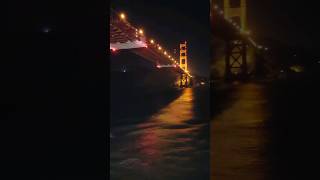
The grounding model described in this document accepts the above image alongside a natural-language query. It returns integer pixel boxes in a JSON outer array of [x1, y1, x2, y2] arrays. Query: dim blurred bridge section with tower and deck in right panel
[[210, 0, 269, 80]]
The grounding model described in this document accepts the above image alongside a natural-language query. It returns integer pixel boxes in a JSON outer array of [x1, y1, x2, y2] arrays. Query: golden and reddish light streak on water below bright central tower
[[136, 88, 195, 168]]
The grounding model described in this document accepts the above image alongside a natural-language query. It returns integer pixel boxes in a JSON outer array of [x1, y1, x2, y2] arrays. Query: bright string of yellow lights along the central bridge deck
[[119, 12, 192, 77]]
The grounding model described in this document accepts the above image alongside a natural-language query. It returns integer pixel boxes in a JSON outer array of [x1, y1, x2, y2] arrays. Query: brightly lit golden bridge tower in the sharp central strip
[[180, 41, 188, 87]]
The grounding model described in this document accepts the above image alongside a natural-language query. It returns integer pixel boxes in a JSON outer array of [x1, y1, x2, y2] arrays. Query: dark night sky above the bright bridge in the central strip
[[111, 0, 210, 76]]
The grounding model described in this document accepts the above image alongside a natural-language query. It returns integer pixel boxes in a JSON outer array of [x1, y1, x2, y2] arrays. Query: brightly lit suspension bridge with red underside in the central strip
[[110, 10, 193, 87]]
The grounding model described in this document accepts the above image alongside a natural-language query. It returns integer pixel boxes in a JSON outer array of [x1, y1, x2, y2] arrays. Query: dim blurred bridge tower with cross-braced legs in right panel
[[224, 0, 248, 79]]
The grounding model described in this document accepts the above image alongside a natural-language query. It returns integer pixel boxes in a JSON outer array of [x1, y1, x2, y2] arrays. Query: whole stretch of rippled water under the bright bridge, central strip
[[110, 87, 210, 180]]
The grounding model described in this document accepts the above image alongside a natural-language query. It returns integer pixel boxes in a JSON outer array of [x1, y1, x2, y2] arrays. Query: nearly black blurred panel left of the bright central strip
[[5, 0, 109, 179]]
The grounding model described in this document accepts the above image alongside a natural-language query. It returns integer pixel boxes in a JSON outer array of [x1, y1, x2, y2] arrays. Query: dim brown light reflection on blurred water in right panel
[[211, 83, 270, 180]]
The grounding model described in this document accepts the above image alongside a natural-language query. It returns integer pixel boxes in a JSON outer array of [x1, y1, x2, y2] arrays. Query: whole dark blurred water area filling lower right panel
[[210, 79, 320, 180]]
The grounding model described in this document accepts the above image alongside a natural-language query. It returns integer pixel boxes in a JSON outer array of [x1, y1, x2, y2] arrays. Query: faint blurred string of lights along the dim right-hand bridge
[[213, 5, 269, 51]]
